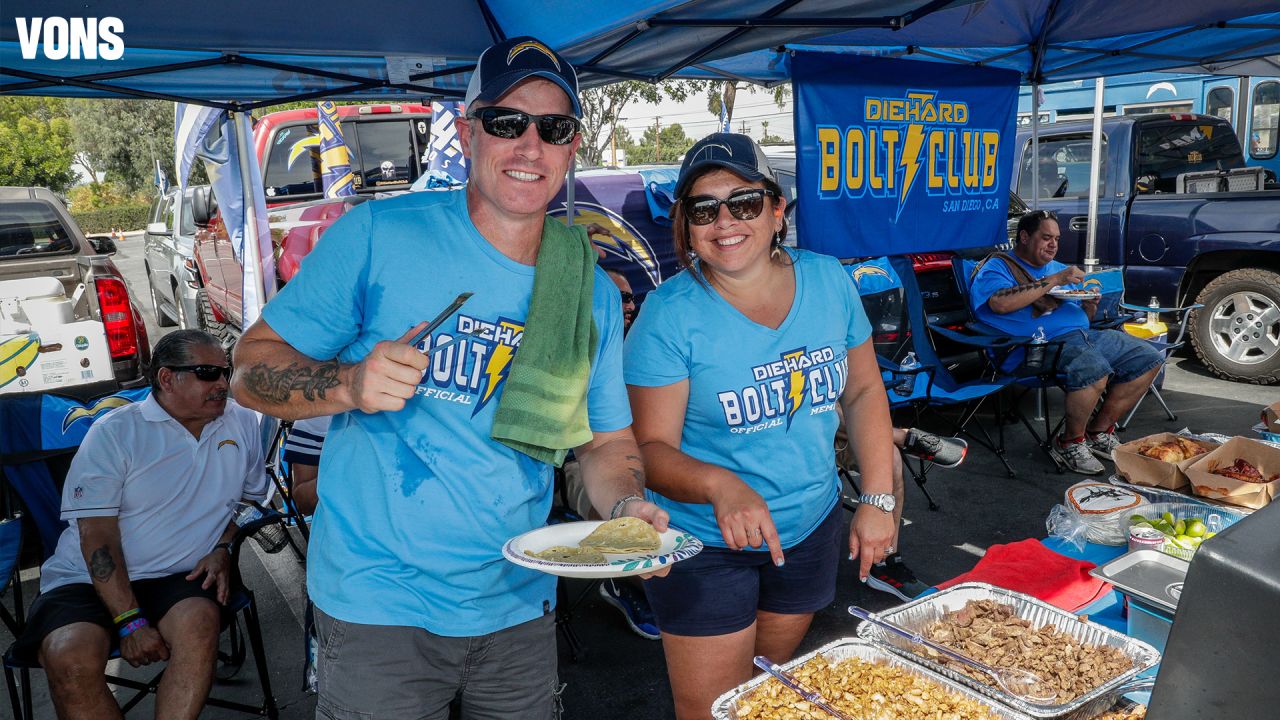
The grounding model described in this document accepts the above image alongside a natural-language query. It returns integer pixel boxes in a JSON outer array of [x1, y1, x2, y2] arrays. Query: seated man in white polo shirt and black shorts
[[18, 331, 268, 719]]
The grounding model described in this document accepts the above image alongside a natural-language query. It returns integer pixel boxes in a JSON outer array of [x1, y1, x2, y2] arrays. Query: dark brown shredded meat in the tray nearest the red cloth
[[924, 600, 1133, 705]]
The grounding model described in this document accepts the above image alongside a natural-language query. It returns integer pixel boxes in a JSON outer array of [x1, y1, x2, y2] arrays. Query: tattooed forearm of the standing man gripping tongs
[[232, 336, 353, 420]]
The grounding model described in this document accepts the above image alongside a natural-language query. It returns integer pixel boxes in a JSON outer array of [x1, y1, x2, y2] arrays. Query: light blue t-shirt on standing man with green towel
[[262, 191, 631, 637]]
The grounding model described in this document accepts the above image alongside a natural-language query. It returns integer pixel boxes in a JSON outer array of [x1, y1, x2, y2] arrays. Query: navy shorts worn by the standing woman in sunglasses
[[644, 502, 845, 637]]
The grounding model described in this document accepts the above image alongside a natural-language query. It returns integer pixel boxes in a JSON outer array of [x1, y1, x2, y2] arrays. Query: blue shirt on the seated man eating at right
[[969, 258, 1089, 370]]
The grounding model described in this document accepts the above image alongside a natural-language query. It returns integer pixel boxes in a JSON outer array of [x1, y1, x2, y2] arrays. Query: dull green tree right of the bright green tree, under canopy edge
[[68, 100, 177, 192]]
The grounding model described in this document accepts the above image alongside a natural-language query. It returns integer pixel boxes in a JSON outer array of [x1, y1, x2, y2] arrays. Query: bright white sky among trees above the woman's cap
[[622, 88, 795, 147]]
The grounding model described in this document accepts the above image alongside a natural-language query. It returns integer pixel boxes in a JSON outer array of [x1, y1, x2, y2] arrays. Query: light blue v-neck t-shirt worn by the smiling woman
[[623, 250, 870, 547]]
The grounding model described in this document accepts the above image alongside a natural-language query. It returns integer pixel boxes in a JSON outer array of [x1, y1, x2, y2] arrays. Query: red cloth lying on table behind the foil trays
[[938, 539, 1111, 612]]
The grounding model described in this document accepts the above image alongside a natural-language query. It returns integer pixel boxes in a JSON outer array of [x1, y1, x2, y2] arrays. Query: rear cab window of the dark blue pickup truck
[[1135, 123, 1244, 192]]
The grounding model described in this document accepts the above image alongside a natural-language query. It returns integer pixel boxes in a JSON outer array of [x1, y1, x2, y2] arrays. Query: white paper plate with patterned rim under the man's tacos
[[502, 520, 703, 578]]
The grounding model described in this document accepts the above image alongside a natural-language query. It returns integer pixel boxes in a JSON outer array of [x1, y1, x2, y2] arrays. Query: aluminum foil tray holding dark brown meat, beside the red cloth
[[858, 583, 1160, 720]]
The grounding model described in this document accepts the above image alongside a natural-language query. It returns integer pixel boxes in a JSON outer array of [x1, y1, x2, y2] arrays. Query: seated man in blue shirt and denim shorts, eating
[[970, 210, 1165, 475]]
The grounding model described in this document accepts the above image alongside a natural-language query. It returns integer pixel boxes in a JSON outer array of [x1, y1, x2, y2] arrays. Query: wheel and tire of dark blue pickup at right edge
[[1189, 268, 1280, 384]]
